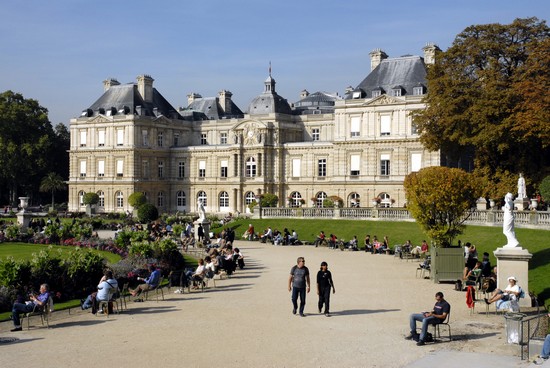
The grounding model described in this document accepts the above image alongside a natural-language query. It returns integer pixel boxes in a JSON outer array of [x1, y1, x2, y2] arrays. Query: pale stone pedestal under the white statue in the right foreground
[[493, 247, 533, 307]]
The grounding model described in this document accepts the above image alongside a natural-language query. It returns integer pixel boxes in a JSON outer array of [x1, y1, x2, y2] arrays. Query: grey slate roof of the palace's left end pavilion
[[81, 83, 181, 119]]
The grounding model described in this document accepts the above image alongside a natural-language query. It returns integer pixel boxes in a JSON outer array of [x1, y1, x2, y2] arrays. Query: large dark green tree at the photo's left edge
[[0, 91, 55, 204]]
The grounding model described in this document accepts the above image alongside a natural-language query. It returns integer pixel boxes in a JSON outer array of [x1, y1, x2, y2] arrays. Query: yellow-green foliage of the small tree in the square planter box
[[404, 166, 479, 245]]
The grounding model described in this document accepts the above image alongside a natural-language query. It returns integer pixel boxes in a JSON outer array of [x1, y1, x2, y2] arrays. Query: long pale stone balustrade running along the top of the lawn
[[253, 207, 550, 230]]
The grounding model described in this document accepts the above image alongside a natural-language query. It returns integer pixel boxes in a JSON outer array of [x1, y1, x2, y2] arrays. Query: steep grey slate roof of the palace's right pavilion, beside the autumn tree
[[345, 56, 427, 99]]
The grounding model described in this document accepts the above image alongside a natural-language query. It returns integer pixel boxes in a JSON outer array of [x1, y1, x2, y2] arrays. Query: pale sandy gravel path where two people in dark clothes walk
[[0, 242, 544, 368]]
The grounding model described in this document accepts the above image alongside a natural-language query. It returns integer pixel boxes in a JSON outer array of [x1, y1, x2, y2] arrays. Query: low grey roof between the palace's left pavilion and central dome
[[180, 97, 244, 120]]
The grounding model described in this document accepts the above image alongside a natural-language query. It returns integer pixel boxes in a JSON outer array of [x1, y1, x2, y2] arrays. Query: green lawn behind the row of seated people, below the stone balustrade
[[226, 219, 550, 308]]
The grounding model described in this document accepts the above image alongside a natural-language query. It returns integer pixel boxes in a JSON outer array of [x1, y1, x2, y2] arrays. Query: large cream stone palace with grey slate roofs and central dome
[[69, 44, 441, 213]]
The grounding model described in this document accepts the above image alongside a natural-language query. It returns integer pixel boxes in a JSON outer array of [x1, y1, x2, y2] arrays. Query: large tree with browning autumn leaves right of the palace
[[414, 18, 550, 184]]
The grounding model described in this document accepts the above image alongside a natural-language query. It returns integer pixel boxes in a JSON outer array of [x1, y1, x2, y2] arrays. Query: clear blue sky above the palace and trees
[[0, 0, 550, 125]]
